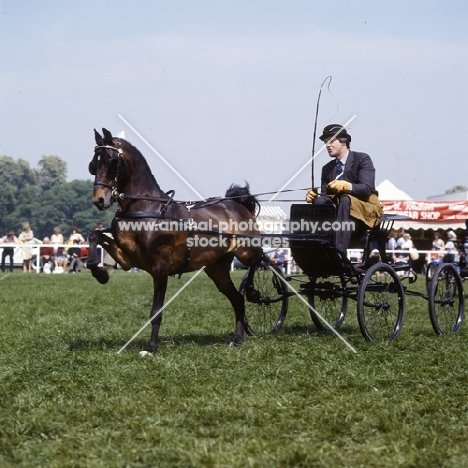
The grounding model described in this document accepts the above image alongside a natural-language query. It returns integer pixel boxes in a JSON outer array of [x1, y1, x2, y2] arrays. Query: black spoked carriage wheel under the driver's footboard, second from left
[[308, 276, 348, 330]]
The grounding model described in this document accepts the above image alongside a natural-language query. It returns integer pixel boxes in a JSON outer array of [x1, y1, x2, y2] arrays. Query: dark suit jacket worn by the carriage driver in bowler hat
[[322, 151, 378, 200]]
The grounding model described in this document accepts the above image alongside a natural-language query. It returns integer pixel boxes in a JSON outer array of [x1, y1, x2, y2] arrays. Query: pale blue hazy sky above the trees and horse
[[0, 0, 468, 204]]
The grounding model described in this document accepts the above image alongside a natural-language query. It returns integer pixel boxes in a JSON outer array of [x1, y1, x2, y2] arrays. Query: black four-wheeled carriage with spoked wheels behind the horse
[[240, 204, 465, 342]]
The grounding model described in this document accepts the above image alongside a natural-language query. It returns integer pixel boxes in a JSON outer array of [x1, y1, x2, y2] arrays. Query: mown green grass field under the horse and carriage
[[0, 271, 468, 468]]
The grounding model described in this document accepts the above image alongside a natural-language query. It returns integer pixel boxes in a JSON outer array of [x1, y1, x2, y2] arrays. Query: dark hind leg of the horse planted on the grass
[[205, 255, 247, 346]]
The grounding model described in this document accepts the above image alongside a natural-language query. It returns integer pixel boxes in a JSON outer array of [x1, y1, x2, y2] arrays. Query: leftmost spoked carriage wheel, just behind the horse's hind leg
[[240, 259, 289, 336]]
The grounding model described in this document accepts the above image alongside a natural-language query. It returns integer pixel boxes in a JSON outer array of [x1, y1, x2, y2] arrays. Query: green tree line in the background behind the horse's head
[[0, 156, 114, 240]]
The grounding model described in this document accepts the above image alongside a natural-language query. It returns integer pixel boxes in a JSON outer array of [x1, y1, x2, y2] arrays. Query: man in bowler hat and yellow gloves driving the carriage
[[306, 124, 384, 252]]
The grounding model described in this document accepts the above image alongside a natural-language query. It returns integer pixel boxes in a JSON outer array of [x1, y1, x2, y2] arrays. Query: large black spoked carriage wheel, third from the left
[[357, 263, 405, 343]]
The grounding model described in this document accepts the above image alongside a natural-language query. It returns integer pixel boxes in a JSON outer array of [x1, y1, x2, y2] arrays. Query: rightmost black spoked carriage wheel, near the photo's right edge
[[429, 263, 465, 335]]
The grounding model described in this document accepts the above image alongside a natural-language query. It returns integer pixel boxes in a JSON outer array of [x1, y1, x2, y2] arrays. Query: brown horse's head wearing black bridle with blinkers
[[88, 128, 127, 210]]
